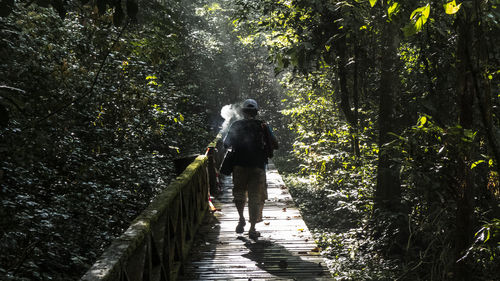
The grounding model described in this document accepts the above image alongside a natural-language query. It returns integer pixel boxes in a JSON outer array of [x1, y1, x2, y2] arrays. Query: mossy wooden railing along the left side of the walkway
[[81, 137, 222, 281]]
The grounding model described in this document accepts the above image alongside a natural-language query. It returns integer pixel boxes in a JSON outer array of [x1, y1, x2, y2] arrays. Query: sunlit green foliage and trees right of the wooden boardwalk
[[235, 0, 500, 280]]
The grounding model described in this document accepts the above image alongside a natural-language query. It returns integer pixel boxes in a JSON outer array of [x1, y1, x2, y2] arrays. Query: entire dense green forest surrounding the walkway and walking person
[[0, 0, 500, 281]]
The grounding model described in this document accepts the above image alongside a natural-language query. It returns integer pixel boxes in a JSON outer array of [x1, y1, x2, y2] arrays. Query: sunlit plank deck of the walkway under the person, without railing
[[179, 164, 333, 280]]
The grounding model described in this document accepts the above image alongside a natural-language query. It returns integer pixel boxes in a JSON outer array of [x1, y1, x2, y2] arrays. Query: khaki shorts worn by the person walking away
[[233, 166, 267, 223]]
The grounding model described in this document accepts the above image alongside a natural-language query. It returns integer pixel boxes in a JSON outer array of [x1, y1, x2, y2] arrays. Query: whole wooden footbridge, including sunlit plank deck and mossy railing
[[81, 136, 332, 281]]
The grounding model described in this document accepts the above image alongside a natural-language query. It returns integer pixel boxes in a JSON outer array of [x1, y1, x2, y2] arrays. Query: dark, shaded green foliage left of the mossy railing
[[0, 1, 248, 280]]
